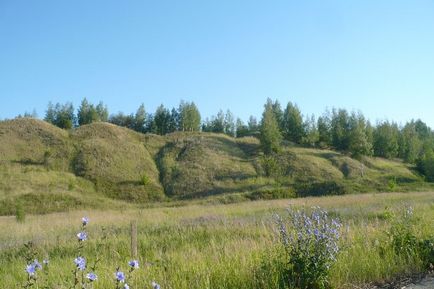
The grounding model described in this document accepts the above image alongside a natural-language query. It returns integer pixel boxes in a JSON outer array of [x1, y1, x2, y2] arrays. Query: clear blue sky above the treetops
[[0, 0, 434, 127]]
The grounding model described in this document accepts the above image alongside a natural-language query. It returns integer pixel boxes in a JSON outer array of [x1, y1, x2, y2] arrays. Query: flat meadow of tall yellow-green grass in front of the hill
[[0, 192, 434, 289]]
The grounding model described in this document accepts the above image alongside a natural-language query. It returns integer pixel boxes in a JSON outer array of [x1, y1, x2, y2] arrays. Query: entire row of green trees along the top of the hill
[[36, 98, 434, 180]]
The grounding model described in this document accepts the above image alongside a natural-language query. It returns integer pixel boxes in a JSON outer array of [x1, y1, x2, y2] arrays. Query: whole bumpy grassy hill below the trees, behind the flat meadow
[[0, 118, 432, 215]]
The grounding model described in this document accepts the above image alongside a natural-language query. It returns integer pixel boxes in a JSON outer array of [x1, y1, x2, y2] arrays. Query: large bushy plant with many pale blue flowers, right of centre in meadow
[[277, 208, 341, 289]]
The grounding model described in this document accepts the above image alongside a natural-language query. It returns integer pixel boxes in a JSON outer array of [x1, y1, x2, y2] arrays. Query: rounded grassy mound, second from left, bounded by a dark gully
[[70, 123, 164, 202]]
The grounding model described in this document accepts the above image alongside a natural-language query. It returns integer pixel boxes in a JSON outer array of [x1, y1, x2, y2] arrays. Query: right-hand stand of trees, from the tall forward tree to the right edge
[[259, 99, 434, 181]]
